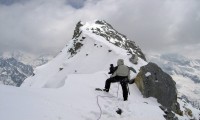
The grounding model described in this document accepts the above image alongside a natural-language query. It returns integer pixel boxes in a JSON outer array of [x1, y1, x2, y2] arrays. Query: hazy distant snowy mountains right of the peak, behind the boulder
[[149, 54, 200, 83]]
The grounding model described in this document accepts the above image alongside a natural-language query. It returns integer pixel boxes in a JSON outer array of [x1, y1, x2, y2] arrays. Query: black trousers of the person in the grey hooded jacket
[[105, 76, 128, 100]]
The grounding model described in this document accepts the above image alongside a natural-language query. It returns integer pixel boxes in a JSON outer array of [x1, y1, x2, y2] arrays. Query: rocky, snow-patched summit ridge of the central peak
[[71, 20, 146, 61]]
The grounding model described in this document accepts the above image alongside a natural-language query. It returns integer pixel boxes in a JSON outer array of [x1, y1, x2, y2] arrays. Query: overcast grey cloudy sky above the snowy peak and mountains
[[0, 0, 200, 58]]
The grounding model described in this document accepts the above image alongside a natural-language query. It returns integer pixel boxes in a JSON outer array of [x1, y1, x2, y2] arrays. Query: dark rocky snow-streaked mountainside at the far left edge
[[0, 58, 33, 87]]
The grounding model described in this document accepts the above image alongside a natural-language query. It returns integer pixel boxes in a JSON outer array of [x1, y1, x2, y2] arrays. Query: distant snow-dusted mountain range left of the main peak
[[0, 51, 53, 87]]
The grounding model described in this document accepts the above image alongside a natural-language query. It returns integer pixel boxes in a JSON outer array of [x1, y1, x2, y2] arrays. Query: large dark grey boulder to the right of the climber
[[135, 62, 180, 114]]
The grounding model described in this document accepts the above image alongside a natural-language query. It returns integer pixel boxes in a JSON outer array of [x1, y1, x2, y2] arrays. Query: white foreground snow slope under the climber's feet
[[0, 72, 164, 120]]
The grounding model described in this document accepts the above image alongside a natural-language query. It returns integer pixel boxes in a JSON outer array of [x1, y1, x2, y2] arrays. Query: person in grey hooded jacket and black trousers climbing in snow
[[103, 59, 134, 101]]
